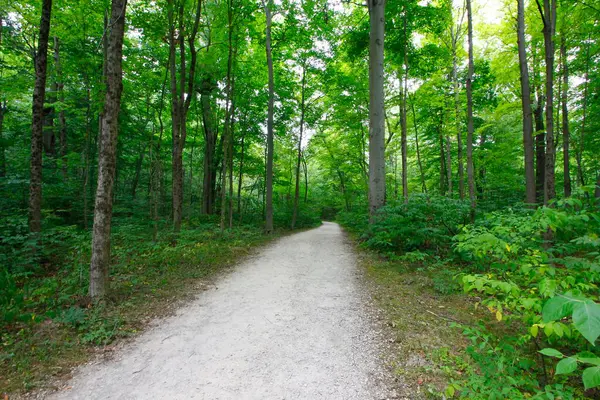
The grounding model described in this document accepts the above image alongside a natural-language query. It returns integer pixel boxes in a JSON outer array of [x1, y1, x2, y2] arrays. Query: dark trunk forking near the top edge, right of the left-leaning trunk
[[536, 0, 556, 205]]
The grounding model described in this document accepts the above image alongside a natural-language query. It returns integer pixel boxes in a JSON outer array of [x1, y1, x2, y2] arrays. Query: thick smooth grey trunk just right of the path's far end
[[368, 0, 385, 223]]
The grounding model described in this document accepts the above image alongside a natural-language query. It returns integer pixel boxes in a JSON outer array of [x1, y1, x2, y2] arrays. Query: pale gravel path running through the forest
[[51, 222, 387, 400]]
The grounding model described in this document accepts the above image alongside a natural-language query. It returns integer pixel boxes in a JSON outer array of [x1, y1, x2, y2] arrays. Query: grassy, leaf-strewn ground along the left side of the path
[[0, 224, 285, 399]]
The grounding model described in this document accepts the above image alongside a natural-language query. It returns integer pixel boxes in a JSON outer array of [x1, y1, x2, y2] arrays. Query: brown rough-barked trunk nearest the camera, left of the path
[[90, 0, 127, 301]]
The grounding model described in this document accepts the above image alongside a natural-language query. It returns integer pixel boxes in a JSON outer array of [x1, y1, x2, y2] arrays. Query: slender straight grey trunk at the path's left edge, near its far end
[[263, 0, 275, 234]]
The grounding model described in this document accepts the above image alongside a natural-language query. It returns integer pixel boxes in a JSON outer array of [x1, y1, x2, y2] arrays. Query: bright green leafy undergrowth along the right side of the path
[[339, 192, 600, 399]]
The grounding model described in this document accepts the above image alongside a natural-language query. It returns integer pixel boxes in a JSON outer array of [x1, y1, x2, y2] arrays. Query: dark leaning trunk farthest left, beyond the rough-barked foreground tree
[[29, 0, 52, 234]]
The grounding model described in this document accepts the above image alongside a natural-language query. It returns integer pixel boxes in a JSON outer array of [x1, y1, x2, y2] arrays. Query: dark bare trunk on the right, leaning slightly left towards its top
[[517, 0, 536, 204]]
